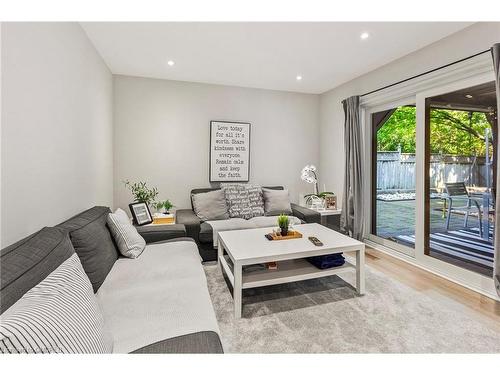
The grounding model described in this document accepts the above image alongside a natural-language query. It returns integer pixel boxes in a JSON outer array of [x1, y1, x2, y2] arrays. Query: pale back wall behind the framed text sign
[[114, 76, 319, 212]]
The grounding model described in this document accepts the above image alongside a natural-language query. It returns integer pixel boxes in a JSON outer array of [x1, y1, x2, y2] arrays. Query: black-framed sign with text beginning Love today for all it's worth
[[210, 121, 250, 182]]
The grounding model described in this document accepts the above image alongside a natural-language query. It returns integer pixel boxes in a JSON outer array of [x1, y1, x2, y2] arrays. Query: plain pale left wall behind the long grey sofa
[[1, 23, 113, 247]]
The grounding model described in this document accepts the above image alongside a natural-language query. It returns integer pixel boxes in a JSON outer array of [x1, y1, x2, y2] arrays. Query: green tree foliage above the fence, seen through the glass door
[[377, 107, 493, 156]]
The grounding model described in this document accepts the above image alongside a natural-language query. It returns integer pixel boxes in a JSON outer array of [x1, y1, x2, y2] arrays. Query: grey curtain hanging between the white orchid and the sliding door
[[340, 96, 363, 240]]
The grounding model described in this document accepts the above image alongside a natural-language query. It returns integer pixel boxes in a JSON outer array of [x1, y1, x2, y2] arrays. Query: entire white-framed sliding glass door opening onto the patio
[[361, 60, 498, 295]]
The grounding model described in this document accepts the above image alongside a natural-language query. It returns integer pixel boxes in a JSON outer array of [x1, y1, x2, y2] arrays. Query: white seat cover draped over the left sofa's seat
[[96, 241, 219, 353]]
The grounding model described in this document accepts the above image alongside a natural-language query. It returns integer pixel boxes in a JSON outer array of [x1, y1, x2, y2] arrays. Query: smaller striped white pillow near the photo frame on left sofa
[[107, 208, 146, 258]]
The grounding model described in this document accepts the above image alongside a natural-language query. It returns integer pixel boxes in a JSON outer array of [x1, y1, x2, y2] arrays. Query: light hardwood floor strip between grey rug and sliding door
[[358, 247, 500, 331]]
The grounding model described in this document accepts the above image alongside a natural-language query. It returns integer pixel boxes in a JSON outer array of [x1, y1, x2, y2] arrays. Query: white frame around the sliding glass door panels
[[360, 54, 500, 301]]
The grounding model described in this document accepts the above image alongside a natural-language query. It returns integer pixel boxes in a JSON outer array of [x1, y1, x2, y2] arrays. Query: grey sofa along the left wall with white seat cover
[[0, 207, 223, 353]]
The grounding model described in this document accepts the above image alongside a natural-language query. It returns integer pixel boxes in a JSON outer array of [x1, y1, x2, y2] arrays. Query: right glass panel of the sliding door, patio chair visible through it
[[424, 82, 498, 276]]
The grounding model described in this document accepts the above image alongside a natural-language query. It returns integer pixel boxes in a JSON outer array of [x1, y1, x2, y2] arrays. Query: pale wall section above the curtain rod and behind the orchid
[[320, 22, 500, 204]]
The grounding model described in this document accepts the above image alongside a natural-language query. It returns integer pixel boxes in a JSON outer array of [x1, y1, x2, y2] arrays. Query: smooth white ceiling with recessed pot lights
[[82, 22, 471, 94]]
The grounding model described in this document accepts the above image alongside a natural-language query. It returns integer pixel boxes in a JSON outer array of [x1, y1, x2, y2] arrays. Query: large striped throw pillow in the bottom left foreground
[[0, 254, 113, 354]]
